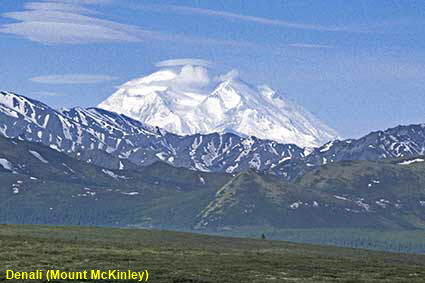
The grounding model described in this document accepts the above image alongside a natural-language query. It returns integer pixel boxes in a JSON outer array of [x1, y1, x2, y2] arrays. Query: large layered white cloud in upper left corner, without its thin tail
[[0, 2, 147, 44]]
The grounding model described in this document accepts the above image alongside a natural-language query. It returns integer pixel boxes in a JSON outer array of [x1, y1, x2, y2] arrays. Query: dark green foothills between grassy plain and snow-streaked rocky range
[[0, 133, 425, 231]]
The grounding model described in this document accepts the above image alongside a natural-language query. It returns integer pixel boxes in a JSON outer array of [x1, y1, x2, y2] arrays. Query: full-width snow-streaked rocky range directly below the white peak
[[0, 92, 425, 181]]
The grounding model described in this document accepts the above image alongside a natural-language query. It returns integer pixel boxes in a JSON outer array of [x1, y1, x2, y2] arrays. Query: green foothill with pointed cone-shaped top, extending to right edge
[[196, 157, 425, 232]]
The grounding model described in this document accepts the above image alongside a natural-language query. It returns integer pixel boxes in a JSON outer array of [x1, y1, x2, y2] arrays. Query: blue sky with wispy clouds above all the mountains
[[0, 0, 425, 140]]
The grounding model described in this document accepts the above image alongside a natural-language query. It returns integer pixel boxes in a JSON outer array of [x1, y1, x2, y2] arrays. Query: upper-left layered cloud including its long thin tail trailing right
[[0, 0, 255, 47]]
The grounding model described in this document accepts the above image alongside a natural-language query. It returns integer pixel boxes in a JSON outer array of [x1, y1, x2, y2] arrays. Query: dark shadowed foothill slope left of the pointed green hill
[[0, 137, 231, 226]]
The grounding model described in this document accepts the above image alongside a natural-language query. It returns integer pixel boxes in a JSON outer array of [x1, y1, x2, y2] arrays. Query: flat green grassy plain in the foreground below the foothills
[[0, 225, 425, 283]]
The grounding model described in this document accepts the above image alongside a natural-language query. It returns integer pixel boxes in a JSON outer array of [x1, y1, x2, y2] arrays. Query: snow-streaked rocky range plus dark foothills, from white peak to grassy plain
[[0, 82, 425, 231]]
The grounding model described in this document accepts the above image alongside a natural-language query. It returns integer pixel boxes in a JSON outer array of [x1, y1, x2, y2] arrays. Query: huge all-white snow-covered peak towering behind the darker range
[[98, 62, 337, 147]]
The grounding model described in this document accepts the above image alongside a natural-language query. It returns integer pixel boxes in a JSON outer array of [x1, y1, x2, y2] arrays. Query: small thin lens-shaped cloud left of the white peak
[[30, 74, 117, 84]]
